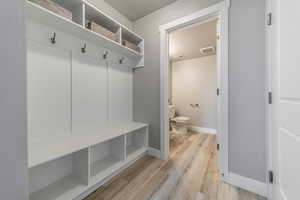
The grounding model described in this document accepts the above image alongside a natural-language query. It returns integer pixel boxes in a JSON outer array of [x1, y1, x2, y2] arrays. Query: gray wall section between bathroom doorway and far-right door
[[229, 0, 266, 182]]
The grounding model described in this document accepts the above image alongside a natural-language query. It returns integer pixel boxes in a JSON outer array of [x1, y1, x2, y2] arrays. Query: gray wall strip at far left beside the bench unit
[[0, 0, 27, 200]]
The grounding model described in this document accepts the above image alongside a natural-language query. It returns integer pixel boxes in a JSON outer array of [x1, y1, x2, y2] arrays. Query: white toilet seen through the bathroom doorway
[[169, 105, 191, 134]]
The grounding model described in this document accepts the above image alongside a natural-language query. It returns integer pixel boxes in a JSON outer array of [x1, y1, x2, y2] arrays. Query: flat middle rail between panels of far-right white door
[[279, 101, 300, 136]]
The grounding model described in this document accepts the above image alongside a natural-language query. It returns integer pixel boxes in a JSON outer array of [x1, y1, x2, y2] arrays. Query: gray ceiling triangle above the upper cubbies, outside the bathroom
[[105, 0, 176, 21]]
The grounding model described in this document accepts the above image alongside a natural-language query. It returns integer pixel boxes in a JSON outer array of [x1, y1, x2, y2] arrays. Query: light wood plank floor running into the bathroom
[[85, 133, 264, 200]]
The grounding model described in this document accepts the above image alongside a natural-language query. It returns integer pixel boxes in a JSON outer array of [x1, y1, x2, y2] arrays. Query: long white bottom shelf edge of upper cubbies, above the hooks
[[25, 0, 143, 60]]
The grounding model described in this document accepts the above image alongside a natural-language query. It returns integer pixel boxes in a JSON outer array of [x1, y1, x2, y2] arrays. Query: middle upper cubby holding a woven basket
[[85, 2, 121, 43]]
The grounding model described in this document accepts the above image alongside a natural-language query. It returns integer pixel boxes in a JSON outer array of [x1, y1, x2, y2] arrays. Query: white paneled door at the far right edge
[[272, 0, 300, 200]]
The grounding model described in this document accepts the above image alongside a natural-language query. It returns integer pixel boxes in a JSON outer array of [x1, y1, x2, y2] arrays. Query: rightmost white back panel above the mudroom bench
[[109, 62, 133, 122]]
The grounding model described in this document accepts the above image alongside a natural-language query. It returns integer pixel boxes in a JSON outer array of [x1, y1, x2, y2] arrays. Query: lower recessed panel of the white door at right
[[279, 129, 300, 199]]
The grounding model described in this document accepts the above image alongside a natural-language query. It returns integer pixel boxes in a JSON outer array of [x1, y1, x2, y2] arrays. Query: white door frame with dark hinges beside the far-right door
[[266, 0, 282, 200]]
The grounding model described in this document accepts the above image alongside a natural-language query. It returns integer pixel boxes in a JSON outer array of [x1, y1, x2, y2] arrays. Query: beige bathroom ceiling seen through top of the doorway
[[170, 20, 217, 61]]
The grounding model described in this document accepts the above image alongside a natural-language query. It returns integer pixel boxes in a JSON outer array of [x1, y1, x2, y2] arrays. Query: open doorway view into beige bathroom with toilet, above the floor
[[168, 18, 218, 151]]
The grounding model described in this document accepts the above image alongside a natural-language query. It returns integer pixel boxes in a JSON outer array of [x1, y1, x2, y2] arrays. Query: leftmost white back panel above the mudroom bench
[[27, 40, 71, 143]]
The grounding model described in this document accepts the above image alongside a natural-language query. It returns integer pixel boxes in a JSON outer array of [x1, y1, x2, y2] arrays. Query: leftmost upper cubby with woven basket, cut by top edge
[[27, 0, 84, 25]]
